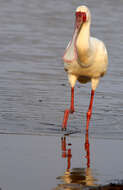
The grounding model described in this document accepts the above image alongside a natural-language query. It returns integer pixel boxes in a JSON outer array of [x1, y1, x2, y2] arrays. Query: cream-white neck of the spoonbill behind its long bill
[[76, 22, 91, 62]]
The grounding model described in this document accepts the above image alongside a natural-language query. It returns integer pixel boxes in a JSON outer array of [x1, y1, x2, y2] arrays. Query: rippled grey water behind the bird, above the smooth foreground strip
[[0, 0, 123, 139]]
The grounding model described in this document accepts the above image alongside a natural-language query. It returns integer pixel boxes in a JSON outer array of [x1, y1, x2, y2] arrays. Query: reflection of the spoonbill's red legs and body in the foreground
[[54, 132, 96, 190]]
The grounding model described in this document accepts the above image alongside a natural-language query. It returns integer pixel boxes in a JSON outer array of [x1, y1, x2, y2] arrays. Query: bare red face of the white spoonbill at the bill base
[[75, 11, 87, 29]]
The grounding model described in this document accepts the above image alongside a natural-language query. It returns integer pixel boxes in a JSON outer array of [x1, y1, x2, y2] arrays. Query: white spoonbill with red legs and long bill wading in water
[[62, 6, 108, 130]]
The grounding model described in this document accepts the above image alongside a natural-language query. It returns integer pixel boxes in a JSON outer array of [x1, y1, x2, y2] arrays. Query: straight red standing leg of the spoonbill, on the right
[[86, 90, 95, 131]]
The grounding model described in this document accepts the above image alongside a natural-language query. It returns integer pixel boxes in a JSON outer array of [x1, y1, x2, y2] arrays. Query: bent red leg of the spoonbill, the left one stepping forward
[[62, 87, 74, 130]]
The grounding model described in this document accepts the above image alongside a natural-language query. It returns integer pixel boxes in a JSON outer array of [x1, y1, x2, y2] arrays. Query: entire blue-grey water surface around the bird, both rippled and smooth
[[0, 0, 123, 190]]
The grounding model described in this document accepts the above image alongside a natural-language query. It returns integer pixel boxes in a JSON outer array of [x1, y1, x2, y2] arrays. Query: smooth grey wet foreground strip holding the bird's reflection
[[0, 134, 123, 190]]
